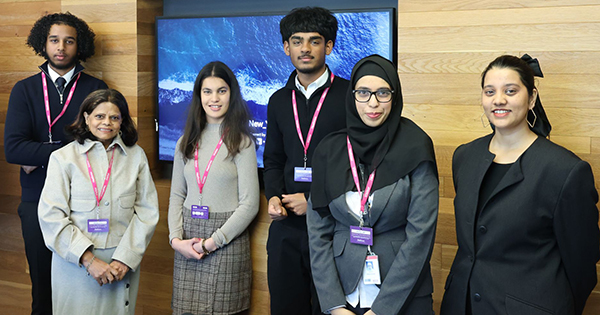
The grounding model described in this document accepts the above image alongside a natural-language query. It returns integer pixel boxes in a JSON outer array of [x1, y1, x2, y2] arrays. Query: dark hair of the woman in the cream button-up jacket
[[65, 89, 138, 147]]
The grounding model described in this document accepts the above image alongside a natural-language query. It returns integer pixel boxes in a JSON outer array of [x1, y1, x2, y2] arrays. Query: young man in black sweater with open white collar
[[264, 7, 348, 315]]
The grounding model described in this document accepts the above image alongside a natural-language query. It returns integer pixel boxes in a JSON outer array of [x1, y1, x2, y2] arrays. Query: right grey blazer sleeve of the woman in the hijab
[[372, 162, 439, 314]]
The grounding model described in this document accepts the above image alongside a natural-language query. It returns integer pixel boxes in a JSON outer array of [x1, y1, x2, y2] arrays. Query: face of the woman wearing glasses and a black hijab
[[354, 75, 392, 127]]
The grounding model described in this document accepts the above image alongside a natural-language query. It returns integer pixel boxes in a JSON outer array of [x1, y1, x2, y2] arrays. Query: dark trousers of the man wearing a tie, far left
[[18, 201, 52, 315]]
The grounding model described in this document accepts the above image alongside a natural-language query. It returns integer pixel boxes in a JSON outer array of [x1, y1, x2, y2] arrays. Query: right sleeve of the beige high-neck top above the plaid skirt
[[211, 140, 260, 248]]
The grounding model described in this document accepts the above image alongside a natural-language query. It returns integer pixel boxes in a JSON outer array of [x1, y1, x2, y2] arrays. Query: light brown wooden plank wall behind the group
[[0, 0, 600, 315]]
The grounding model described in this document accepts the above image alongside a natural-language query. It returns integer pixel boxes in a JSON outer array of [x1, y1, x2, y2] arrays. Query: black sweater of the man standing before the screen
[[264, 71, 349, 227]]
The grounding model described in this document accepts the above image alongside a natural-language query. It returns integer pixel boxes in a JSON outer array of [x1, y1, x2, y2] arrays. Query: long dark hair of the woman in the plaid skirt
[[180, 61, 254, 159]]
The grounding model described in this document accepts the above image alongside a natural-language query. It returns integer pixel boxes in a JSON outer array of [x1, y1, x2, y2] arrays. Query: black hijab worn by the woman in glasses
[[311, 55, 437, 209]]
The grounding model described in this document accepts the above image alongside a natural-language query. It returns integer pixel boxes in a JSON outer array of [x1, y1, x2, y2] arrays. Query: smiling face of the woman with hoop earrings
[[481, 68, 537, 131]]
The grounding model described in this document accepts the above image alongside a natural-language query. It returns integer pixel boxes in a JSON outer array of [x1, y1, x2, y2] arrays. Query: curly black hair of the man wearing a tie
[[27, 12, 96, 61]]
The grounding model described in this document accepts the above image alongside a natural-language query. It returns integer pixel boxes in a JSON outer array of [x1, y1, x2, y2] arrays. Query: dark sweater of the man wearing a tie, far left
[[4, 62, 107, 202]]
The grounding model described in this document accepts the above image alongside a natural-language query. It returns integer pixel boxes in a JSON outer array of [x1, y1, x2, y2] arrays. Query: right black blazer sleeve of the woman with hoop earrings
[[554, 161, 600, 314]]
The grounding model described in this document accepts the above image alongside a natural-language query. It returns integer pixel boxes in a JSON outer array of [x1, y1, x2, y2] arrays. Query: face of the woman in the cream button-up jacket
[[83, 102, 123, 148]]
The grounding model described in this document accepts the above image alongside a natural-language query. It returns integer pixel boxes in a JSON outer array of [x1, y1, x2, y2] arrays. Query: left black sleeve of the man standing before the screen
[[263, 97, 287, 201]]
